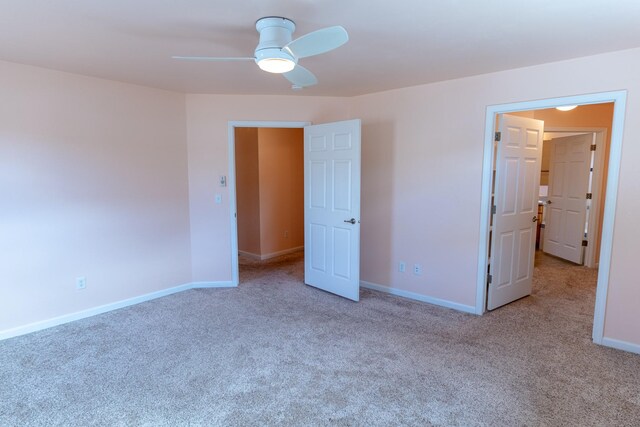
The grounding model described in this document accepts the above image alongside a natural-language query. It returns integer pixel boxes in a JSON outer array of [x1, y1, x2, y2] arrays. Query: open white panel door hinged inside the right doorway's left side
[[487, 114, 544, 310]]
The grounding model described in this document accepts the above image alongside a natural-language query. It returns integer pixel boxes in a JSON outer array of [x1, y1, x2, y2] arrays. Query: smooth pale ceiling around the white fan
[[0, 0, 640, 96]]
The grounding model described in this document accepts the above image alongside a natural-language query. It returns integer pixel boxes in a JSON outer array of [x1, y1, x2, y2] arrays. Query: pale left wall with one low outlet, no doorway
[[0, 62, 191, 333]]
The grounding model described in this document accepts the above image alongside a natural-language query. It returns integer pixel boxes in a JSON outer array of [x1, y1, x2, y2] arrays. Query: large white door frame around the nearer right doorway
[[475, 90, 627, 344]]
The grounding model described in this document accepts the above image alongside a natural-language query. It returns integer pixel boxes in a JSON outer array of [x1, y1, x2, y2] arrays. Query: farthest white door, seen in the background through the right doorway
[[543, 133, 593, 264]]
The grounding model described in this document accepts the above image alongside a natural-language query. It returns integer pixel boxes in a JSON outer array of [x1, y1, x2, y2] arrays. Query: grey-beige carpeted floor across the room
[[0, 255, 640, 426]]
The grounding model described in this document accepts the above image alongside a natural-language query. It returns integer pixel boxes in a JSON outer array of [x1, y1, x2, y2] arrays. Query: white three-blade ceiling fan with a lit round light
[[172, 16, 349, 89]]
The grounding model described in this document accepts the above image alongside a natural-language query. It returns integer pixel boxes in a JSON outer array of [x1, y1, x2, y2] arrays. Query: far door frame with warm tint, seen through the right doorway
[[544, 126, 609, 268]]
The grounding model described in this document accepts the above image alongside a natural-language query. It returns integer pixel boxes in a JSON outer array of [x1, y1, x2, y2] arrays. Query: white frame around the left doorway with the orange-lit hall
[[227, 121, 311, 286]]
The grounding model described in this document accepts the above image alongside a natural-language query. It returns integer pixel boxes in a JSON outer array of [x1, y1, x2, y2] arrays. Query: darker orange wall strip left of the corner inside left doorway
[[235, 128, 260, 254]]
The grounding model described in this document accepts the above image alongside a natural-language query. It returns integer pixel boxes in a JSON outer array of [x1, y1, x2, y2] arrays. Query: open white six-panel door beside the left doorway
[[304, 120, 360, 301]]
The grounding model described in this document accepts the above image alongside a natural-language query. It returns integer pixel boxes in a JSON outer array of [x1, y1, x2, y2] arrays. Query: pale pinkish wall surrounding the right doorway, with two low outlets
[[352, 49, 640, 345]]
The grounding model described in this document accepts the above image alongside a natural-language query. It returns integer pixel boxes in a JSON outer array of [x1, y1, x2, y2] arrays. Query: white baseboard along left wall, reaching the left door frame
[[0, 281, 234, 341]]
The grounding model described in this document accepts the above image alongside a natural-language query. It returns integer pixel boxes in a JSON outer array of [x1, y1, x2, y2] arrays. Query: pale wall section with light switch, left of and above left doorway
[[187, 95, 349, 281]]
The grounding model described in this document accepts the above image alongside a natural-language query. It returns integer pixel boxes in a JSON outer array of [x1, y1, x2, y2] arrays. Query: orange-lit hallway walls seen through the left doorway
[[235, 127, 304, 261]]
